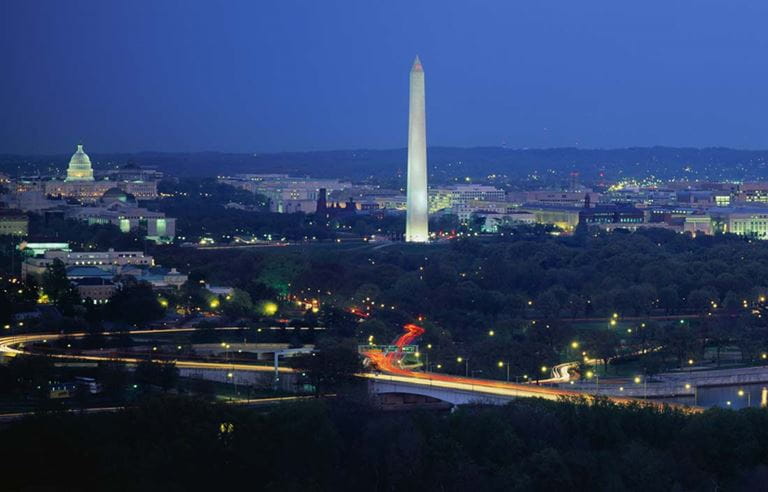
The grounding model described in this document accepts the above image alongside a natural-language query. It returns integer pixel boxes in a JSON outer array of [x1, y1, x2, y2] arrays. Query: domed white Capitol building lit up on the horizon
[[45, 144, 157, 202]]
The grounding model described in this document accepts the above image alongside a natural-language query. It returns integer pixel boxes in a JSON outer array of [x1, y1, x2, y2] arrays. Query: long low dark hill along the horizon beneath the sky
[[0, 147, 768, 182]]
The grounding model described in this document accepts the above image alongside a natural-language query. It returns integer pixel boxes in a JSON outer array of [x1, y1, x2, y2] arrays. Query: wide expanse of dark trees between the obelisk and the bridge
[[141, 228, 768, 376]]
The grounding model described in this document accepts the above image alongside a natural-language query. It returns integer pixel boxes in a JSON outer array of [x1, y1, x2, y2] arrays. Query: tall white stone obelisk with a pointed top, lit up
[[405, 56, 429, 243]]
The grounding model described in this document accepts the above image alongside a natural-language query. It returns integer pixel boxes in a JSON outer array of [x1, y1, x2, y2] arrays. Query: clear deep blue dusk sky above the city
[[0, 0, 768, 153]]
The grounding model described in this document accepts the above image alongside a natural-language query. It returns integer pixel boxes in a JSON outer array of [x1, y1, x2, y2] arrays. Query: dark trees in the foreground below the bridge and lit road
[[0, 398, 768, 492]]
